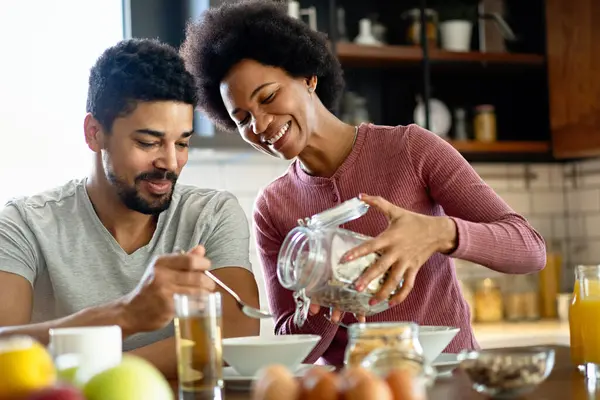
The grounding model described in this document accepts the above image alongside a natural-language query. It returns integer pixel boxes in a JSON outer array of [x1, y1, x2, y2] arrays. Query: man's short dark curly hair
[[86, 39, 196, 132]]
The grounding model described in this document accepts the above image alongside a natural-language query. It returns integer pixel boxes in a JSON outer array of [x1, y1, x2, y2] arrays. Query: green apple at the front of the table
[[83, 354, 175, 400]]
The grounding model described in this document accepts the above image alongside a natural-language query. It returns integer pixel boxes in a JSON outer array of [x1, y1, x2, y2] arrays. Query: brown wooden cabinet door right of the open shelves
[[546, 0, 600, 159]]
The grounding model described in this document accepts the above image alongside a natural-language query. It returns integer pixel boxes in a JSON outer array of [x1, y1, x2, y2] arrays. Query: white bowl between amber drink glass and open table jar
[[223, 335, 321, 377]]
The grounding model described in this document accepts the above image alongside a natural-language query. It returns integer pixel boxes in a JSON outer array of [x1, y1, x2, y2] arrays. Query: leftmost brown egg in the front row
[[251, 364, 300, 400]]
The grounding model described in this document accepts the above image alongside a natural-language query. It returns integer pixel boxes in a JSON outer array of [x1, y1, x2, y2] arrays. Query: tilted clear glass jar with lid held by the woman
[[277, 198, 401, 326]]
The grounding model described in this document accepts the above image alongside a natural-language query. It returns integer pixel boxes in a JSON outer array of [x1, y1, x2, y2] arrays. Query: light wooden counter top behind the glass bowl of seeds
[[473, 320, 569, 348]]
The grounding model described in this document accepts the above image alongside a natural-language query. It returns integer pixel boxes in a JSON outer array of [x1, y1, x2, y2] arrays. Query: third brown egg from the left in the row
[[342, 367, 393, 400]]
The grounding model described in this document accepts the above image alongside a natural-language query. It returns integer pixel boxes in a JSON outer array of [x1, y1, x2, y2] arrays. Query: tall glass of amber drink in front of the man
[[174, 292, 223, 400]]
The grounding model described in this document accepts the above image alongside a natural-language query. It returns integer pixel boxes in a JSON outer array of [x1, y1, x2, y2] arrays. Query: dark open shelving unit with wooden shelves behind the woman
[[322, 0, 553, 162]]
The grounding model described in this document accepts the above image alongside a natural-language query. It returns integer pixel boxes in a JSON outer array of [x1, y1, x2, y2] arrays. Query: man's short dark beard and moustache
[[107, 170, 177, 215]]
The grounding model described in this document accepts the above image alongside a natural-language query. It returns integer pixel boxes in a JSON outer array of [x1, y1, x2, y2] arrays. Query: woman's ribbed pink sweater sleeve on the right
[[406, 125, 546, 274]]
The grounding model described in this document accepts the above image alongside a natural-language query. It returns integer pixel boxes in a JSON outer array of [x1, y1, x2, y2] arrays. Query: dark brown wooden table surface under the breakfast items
[[173, 345, 600, 400]]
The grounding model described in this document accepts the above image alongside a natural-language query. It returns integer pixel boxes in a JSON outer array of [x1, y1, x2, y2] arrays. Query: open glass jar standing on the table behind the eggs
[[344, 322, 423, 367]]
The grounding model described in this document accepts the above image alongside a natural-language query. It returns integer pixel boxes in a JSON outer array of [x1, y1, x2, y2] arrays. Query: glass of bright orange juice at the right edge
[[569, 265, 600, 379]]
